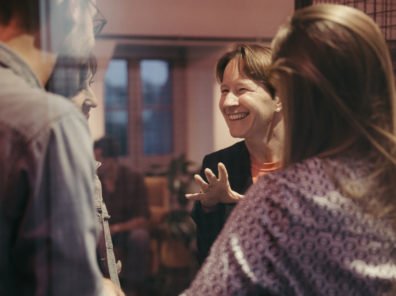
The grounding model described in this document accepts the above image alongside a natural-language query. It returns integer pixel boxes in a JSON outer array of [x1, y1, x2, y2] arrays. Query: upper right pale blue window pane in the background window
[[140, 60, 172, 107]]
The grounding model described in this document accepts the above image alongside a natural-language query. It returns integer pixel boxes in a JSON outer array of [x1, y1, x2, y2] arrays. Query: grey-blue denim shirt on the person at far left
[[0, 43, 102, 296]]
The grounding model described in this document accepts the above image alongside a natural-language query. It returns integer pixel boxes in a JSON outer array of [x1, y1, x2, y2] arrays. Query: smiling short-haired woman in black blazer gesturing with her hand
[[186, 44, 283, 263]]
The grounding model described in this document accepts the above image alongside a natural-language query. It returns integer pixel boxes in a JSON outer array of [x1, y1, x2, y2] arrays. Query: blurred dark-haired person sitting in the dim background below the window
[[94, 136, 150, 295]]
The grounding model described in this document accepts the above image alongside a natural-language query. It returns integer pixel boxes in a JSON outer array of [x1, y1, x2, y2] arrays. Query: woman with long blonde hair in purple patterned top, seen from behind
[[185, 4, 396, 296]]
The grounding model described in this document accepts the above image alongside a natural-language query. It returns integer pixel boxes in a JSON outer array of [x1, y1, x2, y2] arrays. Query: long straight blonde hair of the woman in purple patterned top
[[272, 4, 396, 220]]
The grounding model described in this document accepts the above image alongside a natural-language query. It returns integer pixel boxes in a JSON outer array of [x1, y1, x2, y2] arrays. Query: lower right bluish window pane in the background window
[[143, 110, 173, 155]]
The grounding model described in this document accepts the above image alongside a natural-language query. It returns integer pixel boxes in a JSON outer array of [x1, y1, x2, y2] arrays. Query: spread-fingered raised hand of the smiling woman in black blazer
[[186, 162, 243, 211]]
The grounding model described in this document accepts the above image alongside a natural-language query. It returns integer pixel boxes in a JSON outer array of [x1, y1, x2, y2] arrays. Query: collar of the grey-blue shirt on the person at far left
[[0, 41, 43, 88]]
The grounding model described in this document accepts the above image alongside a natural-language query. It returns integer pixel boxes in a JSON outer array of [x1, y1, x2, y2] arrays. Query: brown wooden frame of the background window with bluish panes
[[108, 44, 187, 172]]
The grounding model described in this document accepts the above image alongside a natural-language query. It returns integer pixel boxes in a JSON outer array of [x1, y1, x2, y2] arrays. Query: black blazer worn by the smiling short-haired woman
[[191, 141, 252, 264]]
